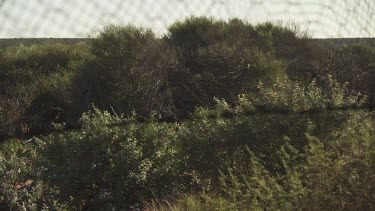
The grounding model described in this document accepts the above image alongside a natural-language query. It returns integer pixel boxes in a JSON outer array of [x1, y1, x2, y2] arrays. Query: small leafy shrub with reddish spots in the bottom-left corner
[[0, 139, 65, 210]]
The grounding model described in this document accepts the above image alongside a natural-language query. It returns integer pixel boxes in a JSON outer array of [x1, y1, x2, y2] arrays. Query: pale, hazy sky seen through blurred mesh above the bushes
[[0, 0, 375, 38]]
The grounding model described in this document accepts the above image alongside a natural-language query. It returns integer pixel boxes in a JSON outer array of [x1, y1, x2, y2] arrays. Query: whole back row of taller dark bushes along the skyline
[[0, 17, 374, 136]]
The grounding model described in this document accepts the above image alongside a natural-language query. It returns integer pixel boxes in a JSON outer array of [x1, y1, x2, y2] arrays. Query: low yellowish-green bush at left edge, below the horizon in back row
[[0, 43, 90, 136]]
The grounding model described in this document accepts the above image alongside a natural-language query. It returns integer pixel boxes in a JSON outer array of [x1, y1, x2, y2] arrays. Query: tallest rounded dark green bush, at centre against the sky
[[164, 17, 298, 116]]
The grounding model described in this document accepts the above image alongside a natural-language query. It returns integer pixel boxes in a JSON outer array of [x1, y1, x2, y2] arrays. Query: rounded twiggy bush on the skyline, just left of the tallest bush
[[73, 25, 178, 116]]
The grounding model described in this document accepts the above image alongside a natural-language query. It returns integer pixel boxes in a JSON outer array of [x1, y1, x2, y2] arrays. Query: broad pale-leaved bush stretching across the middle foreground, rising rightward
[[5, 75, 364, 209]]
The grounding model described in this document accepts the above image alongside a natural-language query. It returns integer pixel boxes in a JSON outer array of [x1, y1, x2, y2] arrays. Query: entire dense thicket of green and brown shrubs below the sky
[[0, 17, 375, 210]]
